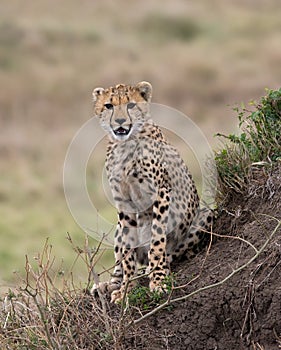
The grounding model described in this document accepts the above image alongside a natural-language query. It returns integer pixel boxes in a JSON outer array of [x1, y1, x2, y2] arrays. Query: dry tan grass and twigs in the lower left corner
[[0, 240, 122, 350]]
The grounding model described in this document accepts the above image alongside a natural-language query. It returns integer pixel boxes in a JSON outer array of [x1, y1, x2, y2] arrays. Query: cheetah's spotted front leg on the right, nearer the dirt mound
[[148, 187, 170, 291]]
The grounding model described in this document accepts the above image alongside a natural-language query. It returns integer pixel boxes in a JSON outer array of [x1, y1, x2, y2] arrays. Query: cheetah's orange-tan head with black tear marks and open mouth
[[93, 81, 152, 141]]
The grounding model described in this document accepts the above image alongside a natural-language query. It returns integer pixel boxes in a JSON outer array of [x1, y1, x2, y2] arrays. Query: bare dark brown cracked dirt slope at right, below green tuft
[[125, 166, 281, 350]]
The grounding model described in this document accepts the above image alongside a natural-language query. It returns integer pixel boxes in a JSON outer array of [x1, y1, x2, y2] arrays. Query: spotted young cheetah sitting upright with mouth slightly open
[[92, 82, 213, 302]]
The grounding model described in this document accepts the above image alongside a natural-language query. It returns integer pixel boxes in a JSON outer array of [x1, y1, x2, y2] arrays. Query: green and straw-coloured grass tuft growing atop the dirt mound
[[215, 88, 281, 198]]
